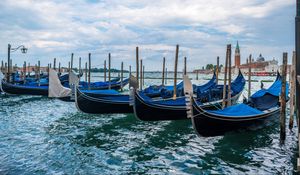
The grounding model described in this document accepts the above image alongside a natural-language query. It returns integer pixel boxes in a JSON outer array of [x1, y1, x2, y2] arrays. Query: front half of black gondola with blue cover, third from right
[[75, 87, 133, 114]]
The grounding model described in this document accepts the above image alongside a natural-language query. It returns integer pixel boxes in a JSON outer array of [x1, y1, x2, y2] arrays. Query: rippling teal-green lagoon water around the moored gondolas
[[0, 74, 297, 175]]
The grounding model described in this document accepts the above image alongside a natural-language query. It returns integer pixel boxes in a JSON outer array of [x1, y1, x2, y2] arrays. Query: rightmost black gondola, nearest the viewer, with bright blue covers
[[187, 74, 288, 136]]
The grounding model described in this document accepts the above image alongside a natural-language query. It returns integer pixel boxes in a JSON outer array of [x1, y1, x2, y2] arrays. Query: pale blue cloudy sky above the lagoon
[[0, 0, 296, 71]]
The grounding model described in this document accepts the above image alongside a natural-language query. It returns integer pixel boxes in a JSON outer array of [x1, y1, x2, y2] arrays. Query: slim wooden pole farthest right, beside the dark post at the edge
[[289, 51, 296, 129]]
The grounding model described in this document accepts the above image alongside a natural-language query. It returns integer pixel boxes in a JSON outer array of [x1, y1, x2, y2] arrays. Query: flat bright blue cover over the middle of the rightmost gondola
[[207, 103, 263, 117]]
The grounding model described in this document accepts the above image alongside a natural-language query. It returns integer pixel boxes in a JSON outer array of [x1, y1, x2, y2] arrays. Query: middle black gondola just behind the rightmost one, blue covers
[[133, 72, 245, 121]]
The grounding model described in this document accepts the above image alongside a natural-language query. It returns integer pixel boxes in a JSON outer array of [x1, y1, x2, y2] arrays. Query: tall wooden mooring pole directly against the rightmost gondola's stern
[[280, 52, 287, 143]]
